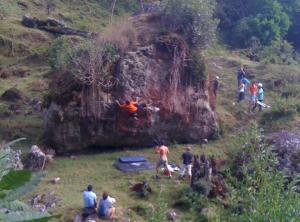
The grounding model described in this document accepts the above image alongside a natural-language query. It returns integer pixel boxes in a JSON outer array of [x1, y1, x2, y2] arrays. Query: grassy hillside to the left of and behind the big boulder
[[0, 0, 142, 143]]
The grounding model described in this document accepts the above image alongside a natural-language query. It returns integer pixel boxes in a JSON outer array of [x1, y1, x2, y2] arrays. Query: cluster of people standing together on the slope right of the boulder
[[237, 65, 264, 112]]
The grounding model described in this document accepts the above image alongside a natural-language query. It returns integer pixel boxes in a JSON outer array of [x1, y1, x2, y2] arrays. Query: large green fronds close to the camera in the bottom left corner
[[0, 139, 58, 222]]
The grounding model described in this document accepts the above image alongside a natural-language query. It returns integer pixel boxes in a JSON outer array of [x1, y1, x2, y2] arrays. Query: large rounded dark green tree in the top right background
[[216, 0, 291, 47]]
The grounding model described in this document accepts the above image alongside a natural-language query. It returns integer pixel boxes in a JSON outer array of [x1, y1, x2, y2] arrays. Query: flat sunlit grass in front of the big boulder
[[26, 140, 231, 221]]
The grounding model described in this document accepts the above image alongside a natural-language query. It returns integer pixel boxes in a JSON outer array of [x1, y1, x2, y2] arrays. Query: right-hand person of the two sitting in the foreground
[[98, 192, 116, 219]]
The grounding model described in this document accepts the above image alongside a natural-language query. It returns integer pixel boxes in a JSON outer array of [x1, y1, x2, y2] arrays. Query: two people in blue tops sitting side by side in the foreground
[[82, 185, 116, 219]]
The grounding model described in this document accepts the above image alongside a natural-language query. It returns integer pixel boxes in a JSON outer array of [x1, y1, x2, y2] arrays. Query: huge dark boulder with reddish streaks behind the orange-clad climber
[[45, 14, 218, 152]]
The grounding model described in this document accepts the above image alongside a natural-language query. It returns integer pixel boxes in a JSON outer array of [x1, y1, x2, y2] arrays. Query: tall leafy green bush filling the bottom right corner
[[223, 123, 300, 221]]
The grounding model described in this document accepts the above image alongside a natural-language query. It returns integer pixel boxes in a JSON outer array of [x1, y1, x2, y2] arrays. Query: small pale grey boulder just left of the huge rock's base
[[26, 145, 46, 171]]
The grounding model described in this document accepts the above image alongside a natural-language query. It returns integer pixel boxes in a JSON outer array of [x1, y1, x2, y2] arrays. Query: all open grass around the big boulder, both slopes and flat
[[0, 0, 300, 221]]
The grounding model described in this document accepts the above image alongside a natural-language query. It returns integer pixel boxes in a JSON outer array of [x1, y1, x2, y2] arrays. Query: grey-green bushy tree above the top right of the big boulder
[[161, 0, 218, 48]]
